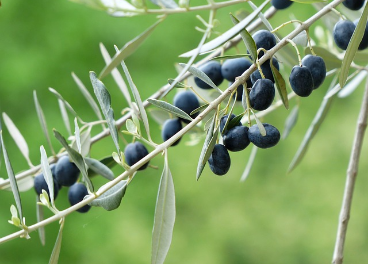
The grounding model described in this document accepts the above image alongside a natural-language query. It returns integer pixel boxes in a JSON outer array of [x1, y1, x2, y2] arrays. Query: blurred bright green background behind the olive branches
[[0, 0, 368, 264]]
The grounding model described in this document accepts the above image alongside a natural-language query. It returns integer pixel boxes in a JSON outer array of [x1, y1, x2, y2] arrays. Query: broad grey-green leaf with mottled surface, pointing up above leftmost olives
[[89, 71, 120, 153]]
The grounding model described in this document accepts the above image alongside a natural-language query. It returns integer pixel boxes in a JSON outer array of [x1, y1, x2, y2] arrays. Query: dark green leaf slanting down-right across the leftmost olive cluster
[[54, 129, 93, 191]]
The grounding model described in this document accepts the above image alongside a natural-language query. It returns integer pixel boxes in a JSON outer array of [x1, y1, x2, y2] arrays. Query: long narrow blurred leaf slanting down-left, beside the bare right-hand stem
[[288, 86, 335, 172]]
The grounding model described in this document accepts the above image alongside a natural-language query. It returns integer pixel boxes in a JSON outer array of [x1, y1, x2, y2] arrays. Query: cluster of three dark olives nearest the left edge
[[34, 156, 91, 213]]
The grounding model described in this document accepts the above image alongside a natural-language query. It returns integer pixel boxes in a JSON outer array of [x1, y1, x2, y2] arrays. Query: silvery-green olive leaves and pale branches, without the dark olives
[[0, 0, 368, 263]]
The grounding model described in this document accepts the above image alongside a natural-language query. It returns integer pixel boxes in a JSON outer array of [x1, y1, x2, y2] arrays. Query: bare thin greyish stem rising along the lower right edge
[[332, 79, 368, 264]]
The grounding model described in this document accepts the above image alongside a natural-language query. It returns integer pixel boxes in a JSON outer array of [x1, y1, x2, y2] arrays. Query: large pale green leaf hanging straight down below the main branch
[[151, 152, 176, 264]]
